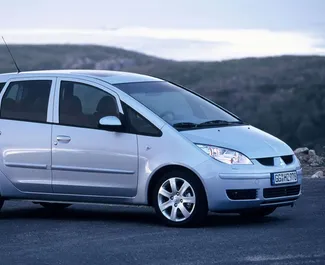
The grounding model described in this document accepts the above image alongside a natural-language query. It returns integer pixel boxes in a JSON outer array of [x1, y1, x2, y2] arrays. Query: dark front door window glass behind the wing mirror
[[59, 81, 119, 129]]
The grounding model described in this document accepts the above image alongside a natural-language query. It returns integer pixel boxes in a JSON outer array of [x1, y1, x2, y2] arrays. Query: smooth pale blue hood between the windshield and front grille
[[180, 125, 293, 158]]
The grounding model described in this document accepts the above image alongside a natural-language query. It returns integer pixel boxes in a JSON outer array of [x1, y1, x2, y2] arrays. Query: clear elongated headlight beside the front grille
[[196, 144, 253, 165]]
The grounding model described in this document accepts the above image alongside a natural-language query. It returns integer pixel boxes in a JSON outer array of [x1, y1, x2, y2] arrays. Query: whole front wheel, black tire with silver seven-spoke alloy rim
[[152, 170, 208, 227]]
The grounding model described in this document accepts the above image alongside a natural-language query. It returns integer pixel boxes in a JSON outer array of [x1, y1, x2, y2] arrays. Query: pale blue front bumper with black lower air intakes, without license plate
[[196, 160, 302, 212]]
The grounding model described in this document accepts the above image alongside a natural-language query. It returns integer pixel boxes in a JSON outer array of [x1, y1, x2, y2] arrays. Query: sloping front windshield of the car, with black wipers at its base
[[115, 81, 241, 129]]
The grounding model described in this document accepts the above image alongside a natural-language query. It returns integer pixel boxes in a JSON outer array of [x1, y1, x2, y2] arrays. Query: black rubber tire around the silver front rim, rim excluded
[[152, 170, 208, 227]]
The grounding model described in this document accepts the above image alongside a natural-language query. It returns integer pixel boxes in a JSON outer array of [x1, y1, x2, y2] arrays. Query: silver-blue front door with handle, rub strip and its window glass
[[52, 79, 138, 197]]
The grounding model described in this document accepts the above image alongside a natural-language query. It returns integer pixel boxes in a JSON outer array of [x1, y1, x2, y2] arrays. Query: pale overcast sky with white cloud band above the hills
[[0, 0, 325, 60]]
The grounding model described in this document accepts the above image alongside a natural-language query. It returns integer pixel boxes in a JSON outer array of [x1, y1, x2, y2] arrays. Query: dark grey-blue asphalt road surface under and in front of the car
[[0, 177, 325, 265]]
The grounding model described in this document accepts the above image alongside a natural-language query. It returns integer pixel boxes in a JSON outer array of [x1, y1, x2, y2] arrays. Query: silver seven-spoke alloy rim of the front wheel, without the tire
[[158, 177, 196, 222]]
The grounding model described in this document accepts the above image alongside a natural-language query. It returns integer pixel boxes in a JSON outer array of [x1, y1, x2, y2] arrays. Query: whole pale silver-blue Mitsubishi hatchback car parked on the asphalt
[[0, 70, 302, 226]]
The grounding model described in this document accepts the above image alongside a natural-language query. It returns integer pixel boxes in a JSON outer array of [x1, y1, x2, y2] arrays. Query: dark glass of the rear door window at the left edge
[[0, 80, 52, 122]]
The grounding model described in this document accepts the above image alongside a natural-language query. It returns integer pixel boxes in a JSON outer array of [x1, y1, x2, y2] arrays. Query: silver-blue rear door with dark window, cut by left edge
[[0, 77, 56, 193]]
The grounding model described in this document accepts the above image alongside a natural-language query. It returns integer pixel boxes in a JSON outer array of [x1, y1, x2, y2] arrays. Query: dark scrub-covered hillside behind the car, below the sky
[[0, 45, 325, 152]]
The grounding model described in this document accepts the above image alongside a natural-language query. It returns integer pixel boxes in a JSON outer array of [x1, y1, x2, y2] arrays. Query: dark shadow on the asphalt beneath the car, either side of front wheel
[[0, 202, 290, 227]]
